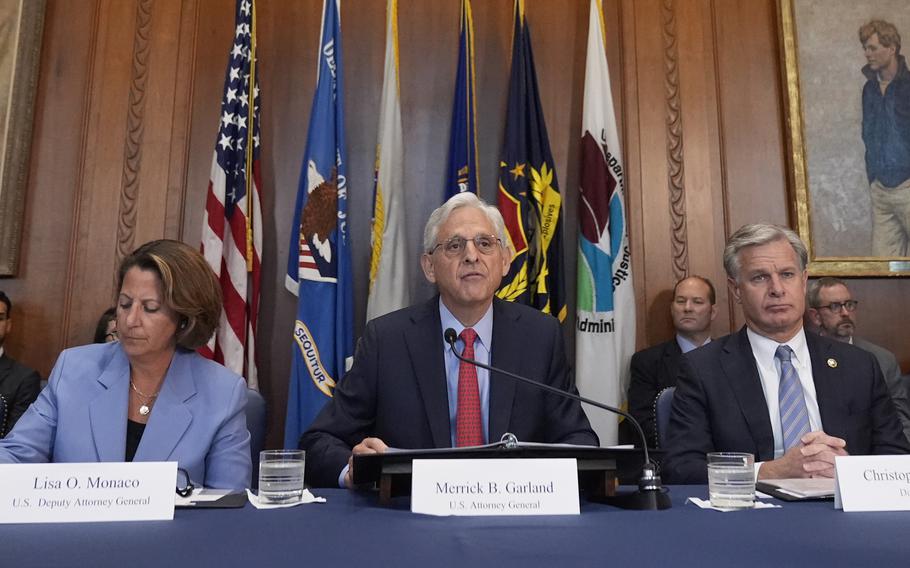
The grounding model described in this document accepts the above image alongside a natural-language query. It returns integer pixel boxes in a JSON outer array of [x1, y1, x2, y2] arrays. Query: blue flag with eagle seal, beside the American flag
[[284, 0, 353, 448]]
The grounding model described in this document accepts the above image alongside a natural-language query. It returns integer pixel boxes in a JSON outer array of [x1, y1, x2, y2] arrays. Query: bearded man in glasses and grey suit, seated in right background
[[806, 276, 910, 440]]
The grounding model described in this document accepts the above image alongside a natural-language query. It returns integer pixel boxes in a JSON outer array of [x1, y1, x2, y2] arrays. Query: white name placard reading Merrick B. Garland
[[411, 459, 579, 516]]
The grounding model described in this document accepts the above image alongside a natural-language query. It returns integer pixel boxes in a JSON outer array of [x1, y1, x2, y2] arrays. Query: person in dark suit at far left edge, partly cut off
[[0, 291, 41, 438]]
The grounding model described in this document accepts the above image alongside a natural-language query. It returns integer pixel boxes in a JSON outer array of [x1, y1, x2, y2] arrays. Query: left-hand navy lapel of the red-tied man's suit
[[404, 296, 452, 448]]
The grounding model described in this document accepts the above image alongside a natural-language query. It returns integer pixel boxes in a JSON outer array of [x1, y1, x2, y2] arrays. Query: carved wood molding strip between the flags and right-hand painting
[[660, 0, 689, 280]]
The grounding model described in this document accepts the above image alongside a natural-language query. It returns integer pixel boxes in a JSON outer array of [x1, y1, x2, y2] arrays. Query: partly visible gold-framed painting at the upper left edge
[[0, 0, 45, 276]]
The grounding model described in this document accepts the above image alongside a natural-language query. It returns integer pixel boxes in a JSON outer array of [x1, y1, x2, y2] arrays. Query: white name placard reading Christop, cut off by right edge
[[834, 455, 910, 512]]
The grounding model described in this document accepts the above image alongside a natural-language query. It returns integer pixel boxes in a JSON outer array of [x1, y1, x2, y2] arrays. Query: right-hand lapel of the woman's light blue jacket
[[134, 350, 196, 461]]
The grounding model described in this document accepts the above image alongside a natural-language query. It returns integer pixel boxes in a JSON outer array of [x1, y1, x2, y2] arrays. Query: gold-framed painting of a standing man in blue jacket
[[778, 0, 910, 276]]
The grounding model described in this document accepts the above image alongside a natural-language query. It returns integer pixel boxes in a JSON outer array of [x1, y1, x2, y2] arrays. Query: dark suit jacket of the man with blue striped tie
[[662, 327, 910, 483]]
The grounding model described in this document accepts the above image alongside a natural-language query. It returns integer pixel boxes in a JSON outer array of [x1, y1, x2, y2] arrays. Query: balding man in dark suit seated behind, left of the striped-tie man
[[632, 275, 717, 447]]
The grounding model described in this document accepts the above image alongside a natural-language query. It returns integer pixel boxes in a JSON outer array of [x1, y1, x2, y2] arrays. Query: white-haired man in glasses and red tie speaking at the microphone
[[300, 193, 598, 487]]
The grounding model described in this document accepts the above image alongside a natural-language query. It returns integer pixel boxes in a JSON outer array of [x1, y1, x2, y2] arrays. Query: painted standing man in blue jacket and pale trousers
[[859, 20, 910, 257]]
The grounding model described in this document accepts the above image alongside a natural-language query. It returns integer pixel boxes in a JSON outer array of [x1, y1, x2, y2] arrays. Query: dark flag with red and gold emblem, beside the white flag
[[496, 0, 566, 321]]
